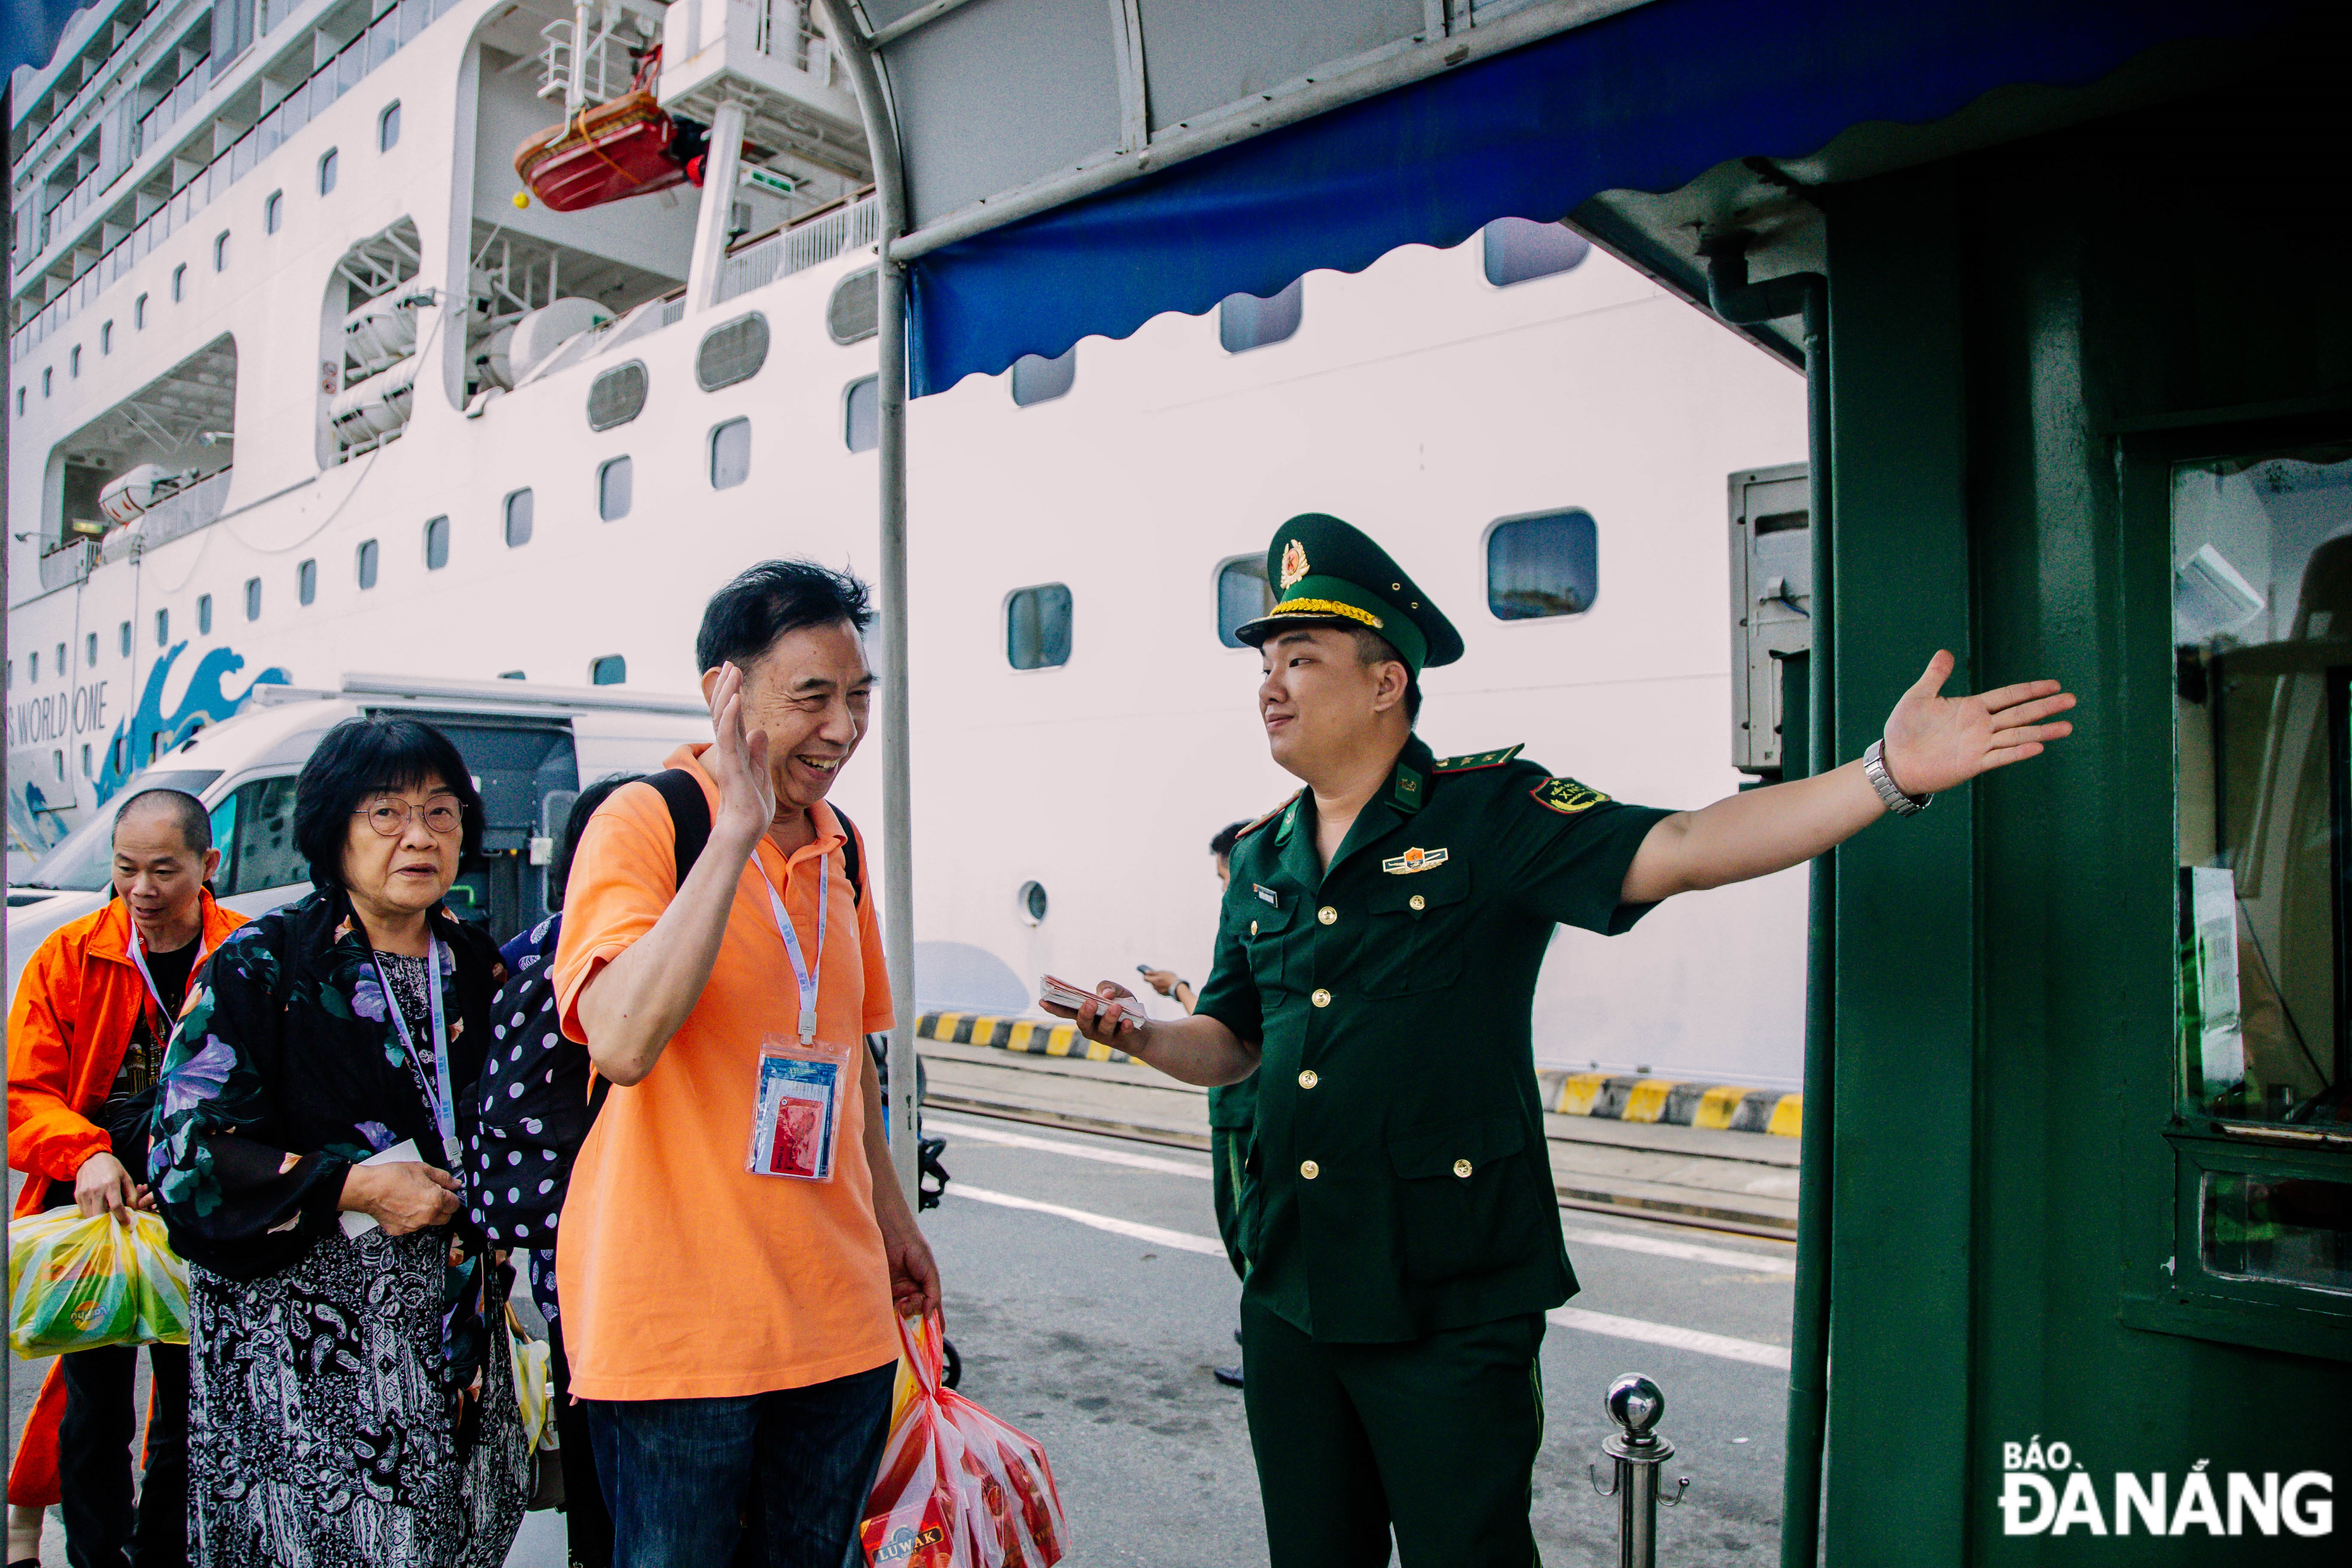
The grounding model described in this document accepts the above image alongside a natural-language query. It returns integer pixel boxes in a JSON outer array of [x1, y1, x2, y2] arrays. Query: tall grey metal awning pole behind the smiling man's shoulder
[[823, 0, 920, 1208]]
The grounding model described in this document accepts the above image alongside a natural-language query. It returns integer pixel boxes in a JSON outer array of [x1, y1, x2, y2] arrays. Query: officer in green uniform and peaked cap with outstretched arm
[[1056, 515, 2074, 1568]]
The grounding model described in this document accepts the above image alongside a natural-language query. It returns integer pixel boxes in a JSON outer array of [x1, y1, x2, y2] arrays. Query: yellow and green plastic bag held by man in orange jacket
[[7, 1208, 188, 1359]]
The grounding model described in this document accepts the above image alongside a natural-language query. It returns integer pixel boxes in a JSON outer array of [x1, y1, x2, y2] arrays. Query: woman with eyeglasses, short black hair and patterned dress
[[150, 717, 529, 1568]]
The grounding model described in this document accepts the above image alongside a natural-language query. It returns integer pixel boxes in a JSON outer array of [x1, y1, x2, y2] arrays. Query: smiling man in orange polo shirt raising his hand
[[555, 562, 938, 1568]]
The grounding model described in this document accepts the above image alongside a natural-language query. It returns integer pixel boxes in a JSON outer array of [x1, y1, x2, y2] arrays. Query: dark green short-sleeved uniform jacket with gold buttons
[[1195, 738, 1665, 1342]]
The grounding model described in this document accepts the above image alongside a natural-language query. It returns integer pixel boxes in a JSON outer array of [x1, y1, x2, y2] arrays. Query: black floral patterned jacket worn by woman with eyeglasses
[[148, 888, 505, 1368]]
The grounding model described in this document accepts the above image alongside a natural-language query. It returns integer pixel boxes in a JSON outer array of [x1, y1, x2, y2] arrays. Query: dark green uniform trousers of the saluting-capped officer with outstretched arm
[[1242, 1298, 1543, 1568]]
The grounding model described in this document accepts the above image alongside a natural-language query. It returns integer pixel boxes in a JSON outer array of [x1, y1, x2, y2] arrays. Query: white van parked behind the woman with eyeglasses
[[7, 675, 710, 992]]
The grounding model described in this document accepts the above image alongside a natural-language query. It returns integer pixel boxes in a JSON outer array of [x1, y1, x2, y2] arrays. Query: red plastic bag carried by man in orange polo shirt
[[861, 1312, 1068, 1568]]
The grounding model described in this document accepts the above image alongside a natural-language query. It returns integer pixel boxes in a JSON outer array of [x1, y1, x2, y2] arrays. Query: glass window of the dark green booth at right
[[2171, 447, 2352, 1293]]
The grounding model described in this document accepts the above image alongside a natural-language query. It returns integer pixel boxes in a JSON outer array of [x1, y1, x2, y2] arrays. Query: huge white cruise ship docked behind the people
[[5, 0, 1806, 1088]]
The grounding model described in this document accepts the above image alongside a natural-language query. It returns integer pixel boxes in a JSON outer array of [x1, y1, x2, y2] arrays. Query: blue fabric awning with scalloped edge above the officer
[[910, 0, 2305, 397]]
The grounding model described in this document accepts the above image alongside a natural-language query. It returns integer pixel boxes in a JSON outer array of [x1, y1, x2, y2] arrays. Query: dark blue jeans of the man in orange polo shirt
[[581, 1361, 898, 1568]]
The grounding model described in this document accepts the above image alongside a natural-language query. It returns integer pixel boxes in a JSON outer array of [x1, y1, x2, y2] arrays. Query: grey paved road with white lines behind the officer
[[9, 1112, 1792, 1568]]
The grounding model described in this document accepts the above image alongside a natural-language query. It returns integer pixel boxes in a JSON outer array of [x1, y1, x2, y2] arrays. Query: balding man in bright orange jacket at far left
[[7, 790, 245, 1568]]
